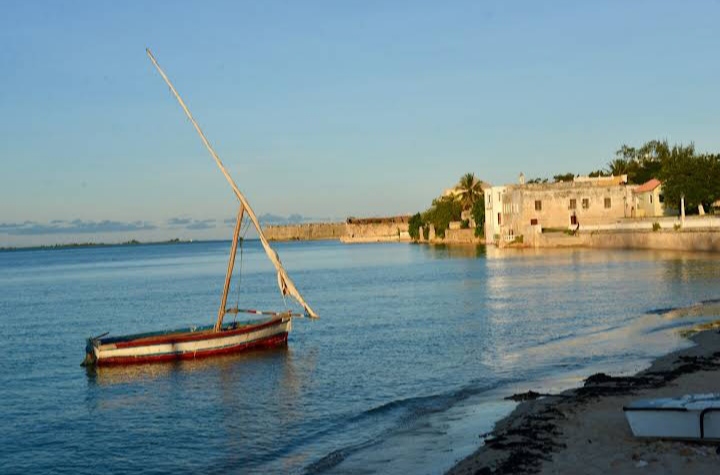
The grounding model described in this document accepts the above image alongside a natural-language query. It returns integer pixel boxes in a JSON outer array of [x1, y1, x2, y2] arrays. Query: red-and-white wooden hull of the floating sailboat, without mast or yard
[[84, 316, 292, 366]]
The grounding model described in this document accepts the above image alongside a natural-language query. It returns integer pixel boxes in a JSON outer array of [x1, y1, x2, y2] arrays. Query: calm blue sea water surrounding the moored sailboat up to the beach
[[0, 242, 720, 474]]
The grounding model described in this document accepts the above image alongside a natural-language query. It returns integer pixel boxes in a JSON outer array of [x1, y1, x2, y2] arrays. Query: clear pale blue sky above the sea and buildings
[[0, 0, 720, 247]]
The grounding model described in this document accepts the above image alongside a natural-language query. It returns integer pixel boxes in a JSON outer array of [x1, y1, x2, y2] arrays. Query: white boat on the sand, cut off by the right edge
[[623, 393, 720, 440]]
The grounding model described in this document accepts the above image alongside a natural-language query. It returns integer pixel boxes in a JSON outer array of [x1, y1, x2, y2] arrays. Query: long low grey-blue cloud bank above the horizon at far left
[[0, 219, 157, 236]]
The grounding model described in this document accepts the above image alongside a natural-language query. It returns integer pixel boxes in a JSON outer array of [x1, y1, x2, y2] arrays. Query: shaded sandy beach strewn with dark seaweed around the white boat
[[448, 329, 720, 475]]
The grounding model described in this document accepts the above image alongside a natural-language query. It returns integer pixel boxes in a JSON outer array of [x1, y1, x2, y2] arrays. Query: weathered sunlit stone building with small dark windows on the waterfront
[[485, 175, 634, 244]]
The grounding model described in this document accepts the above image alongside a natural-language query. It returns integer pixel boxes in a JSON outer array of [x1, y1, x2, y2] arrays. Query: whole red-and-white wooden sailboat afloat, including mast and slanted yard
[[83, 49, 317, 366]]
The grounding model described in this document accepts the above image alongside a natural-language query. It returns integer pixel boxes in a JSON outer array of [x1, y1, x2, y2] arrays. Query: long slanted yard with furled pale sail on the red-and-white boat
[[145, 48, 317, 318]]
